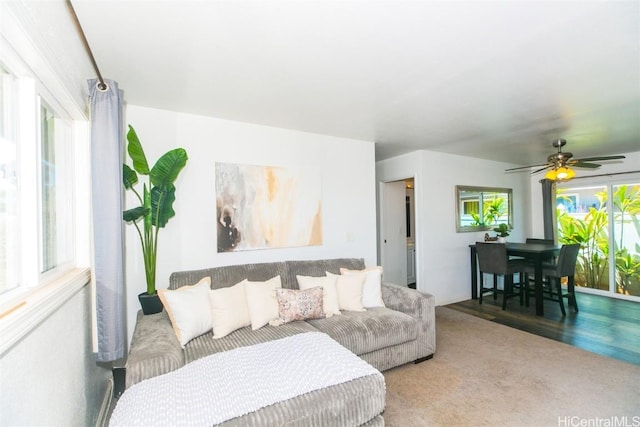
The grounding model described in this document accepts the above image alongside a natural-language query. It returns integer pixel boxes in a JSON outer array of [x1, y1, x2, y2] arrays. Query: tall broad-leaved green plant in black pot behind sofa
[[122, 125, 188, 314]]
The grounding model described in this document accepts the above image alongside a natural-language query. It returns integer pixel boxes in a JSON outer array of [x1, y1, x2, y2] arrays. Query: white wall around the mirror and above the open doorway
[[376, 150, 531, 305]]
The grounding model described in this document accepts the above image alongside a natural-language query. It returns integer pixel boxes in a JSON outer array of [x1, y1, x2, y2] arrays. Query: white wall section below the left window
[[0, 285, 111, 426]]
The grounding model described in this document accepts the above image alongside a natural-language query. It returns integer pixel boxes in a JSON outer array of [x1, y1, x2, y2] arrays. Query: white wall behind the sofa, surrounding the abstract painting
[[125, 106, 376, 342]]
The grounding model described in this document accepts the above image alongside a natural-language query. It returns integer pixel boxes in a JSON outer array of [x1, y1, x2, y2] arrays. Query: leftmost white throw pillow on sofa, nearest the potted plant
[[158, 277, 213, 348]]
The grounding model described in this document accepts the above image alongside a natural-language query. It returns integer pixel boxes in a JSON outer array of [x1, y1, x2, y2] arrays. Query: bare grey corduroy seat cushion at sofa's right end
[[306, 307, 418, 355]]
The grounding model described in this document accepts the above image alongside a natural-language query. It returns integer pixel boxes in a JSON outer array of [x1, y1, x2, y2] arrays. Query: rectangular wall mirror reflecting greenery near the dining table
[[456, 185, 513, 233]]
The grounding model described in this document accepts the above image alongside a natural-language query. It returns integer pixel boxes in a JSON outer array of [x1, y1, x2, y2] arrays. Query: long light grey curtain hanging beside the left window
[[89, 79, 126, 362]]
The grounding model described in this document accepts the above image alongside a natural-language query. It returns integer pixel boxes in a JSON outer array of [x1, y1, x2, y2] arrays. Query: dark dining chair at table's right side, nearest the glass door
[[524, 243, 580, 316]]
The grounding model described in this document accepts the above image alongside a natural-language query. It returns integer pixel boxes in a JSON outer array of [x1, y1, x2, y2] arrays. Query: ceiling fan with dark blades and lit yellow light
[[505, 139, 625, 181]]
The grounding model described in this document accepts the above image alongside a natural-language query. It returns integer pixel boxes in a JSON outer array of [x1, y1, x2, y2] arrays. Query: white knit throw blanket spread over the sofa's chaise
[[110, 332, 382, 426]]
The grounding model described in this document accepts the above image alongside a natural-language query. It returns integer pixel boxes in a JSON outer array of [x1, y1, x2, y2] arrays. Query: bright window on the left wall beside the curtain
[[0, 64, 74, 297]]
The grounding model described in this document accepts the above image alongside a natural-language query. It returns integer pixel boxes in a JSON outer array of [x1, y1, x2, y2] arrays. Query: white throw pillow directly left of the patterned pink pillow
[[243, 276, 282, 331]]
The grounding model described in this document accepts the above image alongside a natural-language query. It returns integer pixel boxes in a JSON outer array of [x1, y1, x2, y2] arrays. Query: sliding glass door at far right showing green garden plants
[[556, 183, 640, 299]]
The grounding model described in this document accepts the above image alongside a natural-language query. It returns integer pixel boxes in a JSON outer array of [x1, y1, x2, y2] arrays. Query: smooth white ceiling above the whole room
[[73, 0, 640, 164]]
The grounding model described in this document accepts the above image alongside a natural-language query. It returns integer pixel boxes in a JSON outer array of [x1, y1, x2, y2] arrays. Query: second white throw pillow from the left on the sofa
[[209, 281, 251, 338]]
